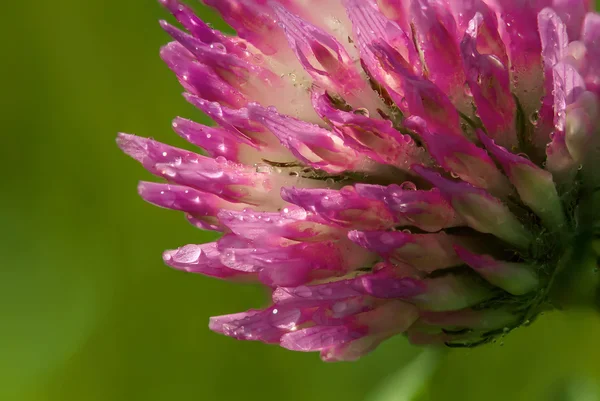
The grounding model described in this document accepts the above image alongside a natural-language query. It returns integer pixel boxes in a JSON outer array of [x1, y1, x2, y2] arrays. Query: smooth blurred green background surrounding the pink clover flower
[[0, 0, 600, 401]]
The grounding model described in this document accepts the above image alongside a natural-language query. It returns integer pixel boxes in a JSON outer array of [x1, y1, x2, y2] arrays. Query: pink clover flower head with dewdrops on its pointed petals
[[118, 0, 600, 361]]
